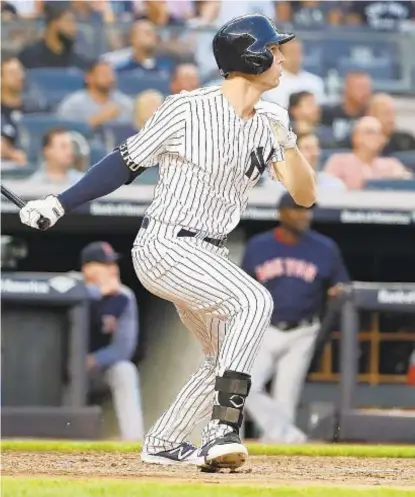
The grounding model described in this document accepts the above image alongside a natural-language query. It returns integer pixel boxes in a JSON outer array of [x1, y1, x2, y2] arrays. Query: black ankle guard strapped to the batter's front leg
[[212, 371, 251, 430]]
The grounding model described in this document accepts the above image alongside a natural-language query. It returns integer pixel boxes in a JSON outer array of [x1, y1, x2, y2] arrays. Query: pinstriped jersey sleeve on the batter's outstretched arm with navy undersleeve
[[118, 94, 189, 176]]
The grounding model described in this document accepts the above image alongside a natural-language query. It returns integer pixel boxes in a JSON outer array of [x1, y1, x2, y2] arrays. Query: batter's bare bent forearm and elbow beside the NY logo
[[274, 147, 317, 207]]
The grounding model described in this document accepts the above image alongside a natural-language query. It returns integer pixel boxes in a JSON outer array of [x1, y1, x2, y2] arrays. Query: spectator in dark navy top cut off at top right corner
[[346, 0, 415, 31]]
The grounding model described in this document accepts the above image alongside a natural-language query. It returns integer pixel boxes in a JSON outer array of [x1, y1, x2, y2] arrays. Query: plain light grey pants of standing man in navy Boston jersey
[[245, 322, 320, 443]]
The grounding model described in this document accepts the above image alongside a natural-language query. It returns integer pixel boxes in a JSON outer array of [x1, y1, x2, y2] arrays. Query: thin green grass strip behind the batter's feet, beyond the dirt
[[1, 440, 415, 458]]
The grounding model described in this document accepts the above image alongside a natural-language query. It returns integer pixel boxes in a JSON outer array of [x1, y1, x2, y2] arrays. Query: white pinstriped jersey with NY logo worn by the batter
[[121, 87, 288, 237]]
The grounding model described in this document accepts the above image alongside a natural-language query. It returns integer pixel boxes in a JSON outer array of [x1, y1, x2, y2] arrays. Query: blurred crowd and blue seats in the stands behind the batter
[[1, 0, 415, 190]]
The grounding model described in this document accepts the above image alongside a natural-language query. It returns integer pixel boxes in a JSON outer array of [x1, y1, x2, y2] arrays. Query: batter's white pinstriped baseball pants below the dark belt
[[132, 220, 273, 452]]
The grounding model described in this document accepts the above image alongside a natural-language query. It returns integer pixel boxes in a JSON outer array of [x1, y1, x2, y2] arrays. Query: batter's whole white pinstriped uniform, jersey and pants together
[[120, 87, 289, 453]]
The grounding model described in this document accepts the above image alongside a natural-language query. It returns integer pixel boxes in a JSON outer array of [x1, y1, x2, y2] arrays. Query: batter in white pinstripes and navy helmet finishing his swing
[[20, 15, 315, 470]]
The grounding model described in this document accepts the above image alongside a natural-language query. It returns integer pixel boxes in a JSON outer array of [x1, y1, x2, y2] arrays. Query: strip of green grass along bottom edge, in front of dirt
[[2, 476, 415, 497]]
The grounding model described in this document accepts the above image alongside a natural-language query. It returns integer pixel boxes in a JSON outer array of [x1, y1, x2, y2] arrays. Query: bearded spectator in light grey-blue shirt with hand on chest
[[57, 60, 133, 128]]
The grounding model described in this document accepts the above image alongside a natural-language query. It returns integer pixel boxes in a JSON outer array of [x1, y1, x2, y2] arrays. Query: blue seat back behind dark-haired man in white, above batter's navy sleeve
[[19, 114, 92, 161]]
